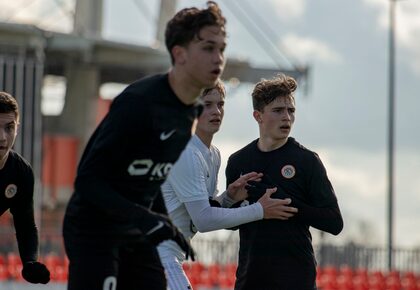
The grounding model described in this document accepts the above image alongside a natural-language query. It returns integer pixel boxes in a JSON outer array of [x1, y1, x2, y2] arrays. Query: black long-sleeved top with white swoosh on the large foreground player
[[64, 74, 197, 242]]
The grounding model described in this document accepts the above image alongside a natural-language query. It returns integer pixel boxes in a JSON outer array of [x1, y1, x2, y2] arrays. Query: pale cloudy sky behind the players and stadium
[[0, 0, 420, 247]]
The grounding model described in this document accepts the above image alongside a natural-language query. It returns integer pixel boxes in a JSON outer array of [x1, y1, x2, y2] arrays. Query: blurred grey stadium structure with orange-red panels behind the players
[[0, 0, 307, 254]]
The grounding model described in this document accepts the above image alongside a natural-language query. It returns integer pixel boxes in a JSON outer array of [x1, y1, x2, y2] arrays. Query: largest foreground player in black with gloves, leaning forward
[[63, 1, 226, 290]]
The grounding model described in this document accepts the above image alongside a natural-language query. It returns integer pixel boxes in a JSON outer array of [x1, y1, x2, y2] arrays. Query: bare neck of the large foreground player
[[169, 68, 202, 105]]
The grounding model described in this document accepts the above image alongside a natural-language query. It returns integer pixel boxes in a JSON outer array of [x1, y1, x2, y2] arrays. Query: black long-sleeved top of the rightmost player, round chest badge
[[226, 137, 343, 290]]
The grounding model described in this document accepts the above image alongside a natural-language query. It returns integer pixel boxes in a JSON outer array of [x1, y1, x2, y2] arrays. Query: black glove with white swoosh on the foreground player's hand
[[142, 213, 195, 261]]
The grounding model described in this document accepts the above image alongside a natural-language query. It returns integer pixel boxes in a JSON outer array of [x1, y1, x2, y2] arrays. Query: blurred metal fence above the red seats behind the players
[[0, 225, 420, 273]]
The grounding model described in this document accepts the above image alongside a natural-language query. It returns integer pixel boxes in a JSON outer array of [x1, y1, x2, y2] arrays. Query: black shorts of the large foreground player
[[64, 233, 167, 290]]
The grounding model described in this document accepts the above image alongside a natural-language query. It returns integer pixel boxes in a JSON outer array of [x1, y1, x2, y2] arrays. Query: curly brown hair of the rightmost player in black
[[252, 74, 297, 111]]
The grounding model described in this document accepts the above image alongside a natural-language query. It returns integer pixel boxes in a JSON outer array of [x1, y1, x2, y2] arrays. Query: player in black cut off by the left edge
[[0, 92, 50, 284]]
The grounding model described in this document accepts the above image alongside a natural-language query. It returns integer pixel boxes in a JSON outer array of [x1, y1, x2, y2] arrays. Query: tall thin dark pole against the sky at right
[[388, 0, 396, 271]]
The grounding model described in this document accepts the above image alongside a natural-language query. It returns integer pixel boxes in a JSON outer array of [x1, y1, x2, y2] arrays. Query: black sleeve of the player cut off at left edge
[[10, 169, 38, 263]]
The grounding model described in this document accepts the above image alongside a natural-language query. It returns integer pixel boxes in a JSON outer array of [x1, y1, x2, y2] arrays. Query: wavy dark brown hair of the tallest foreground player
[[165, 1, 226, 64]]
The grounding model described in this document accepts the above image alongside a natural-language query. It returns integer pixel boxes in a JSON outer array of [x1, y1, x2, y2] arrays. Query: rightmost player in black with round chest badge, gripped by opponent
[[226, 75, 343, 290]]
